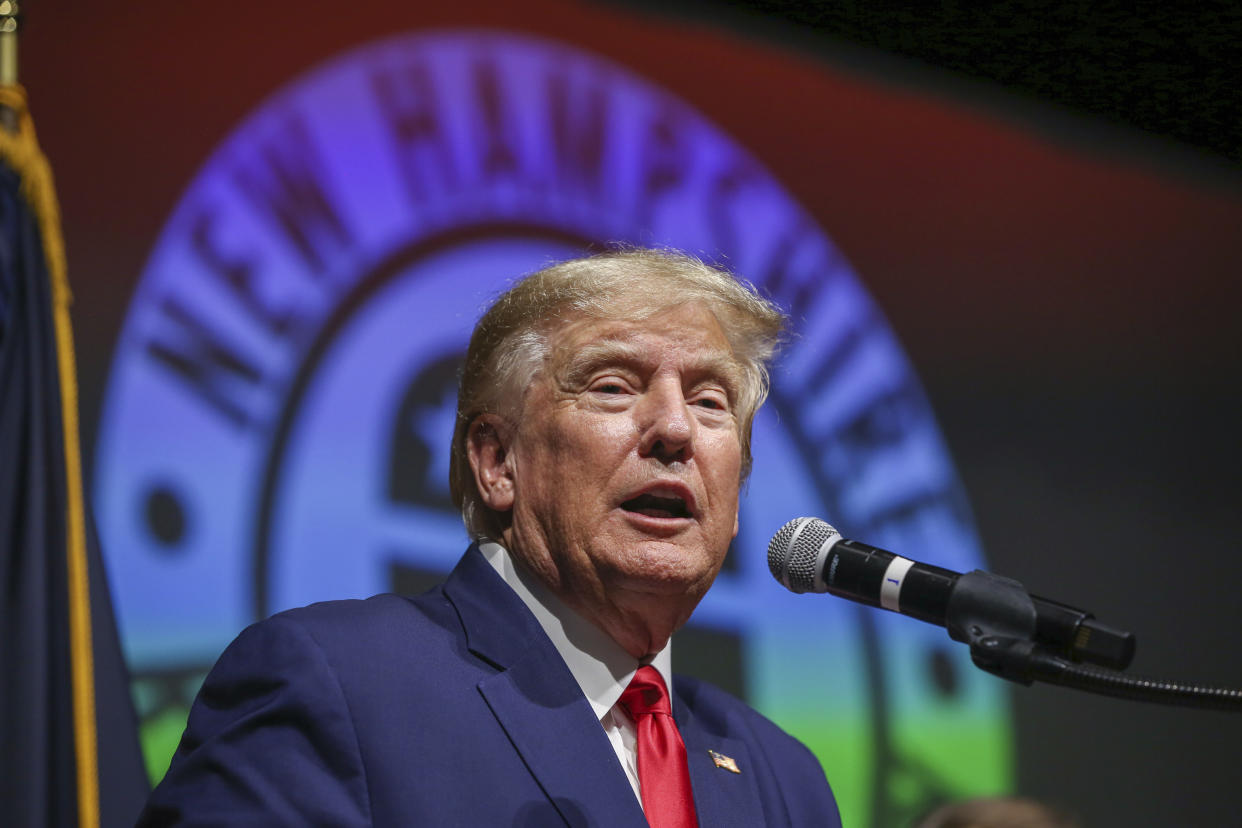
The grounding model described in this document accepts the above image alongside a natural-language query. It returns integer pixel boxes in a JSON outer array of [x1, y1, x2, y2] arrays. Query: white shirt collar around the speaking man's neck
[[478, 540, 673, 719]]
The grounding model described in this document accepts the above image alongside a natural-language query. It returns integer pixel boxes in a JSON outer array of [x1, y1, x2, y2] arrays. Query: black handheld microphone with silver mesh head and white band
[[768, 518, 1134, 669]]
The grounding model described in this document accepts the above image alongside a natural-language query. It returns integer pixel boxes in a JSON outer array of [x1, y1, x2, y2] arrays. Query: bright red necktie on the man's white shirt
[[620, 665, 698, 828]]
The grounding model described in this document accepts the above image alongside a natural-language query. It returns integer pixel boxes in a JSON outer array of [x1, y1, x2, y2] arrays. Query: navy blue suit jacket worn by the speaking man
[[139, 547, 841, 828]]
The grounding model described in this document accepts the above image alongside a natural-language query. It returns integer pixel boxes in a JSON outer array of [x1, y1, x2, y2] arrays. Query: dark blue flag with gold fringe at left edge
[[0, 86, 148, 828]]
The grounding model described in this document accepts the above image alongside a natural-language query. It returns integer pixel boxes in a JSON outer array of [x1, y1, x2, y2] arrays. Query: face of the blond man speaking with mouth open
[[494, 304, 741, 645]]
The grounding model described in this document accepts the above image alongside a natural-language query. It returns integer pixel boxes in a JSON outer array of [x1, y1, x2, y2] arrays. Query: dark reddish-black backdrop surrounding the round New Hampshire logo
[[22, 0, 1242, 826]]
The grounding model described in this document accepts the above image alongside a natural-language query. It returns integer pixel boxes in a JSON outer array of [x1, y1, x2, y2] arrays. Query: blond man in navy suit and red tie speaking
[[143, 251, 840, 828]]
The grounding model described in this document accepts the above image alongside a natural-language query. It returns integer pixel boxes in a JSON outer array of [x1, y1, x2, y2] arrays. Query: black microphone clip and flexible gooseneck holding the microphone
[[945, 570, 1242, 711]]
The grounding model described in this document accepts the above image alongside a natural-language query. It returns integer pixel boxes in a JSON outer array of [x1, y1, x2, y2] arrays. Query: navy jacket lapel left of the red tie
[[445, 549, 647, 827]]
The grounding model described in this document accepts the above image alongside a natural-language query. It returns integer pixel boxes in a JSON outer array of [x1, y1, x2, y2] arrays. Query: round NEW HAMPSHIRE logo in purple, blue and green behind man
[[94, 31, 1010, 824]]
